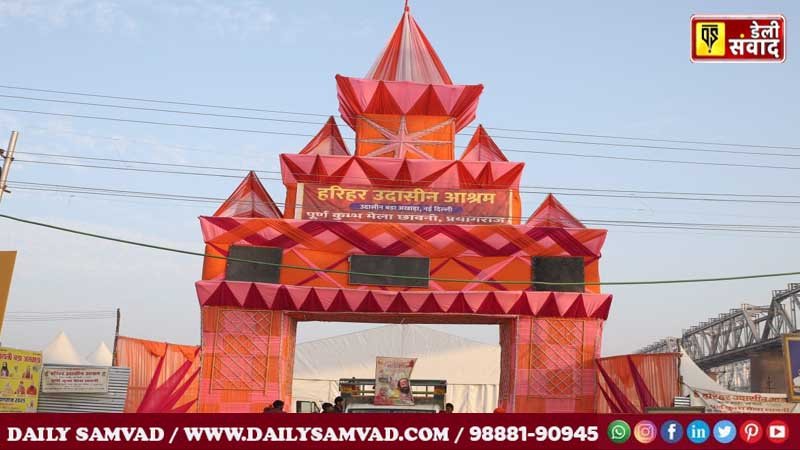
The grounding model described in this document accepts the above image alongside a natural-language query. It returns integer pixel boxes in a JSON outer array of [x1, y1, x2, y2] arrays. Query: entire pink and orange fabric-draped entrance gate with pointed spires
[[189, 3, 611, 412]]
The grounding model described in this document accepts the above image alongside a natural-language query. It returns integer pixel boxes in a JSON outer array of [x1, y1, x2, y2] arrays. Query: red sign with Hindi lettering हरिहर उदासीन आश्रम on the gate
[[295, 184, 512, 225]]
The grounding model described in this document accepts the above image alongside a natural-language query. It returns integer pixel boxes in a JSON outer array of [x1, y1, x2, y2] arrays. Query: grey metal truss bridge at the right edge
[[637, 283, 800, 369]]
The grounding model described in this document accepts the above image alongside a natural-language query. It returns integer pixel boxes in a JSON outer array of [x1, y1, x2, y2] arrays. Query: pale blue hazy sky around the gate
[[0, 0, 800, 355]]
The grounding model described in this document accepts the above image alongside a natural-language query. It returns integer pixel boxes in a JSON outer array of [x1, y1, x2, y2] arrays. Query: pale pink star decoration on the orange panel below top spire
[[361, 116, 453, 159]]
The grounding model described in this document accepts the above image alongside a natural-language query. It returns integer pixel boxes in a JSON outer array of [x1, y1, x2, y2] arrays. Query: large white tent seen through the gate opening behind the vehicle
[[292, 325, 500, 412]]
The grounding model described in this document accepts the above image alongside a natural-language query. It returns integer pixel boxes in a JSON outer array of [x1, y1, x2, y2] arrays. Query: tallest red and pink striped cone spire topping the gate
[[366, 1, 453, 84]]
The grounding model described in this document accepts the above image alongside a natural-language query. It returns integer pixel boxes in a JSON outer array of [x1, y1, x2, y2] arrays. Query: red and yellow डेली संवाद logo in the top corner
[[690, 14, 786, 63]]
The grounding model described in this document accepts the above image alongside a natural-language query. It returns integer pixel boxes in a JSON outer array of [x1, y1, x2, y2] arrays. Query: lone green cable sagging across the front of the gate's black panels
[[0, 214, 800, 286]]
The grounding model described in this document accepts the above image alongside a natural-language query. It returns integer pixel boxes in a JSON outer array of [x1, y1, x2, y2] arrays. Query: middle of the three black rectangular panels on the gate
[[350, 255, 430, 287]]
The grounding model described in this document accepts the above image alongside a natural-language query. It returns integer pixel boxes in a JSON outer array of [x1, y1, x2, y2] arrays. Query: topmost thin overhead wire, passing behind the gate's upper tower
[[0, 85, 800, 155]]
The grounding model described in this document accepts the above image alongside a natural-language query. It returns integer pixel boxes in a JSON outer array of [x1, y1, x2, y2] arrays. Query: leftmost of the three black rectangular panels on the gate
[[225, 245, 283, 283]]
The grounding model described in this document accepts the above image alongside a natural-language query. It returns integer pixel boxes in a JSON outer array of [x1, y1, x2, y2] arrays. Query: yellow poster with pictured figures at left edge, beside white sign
[[0, 347, 42, 413]]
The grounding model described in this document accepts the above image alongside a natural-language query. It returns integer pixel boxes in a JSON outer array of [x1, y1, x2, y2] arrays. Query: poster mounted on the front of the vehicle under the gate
[[374, 356, 417, 406]]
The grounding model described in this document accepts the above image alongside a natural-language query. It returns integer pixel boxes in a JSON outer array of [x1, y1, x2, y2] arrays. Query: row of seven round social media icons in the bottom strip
[[608, 420, 789, 444]]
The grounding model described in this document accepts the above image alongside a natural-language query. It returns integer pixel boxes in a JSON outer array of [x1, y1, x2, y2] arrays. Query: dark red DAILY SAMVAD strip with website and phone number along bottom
[[0, 413, 800, 450]]
